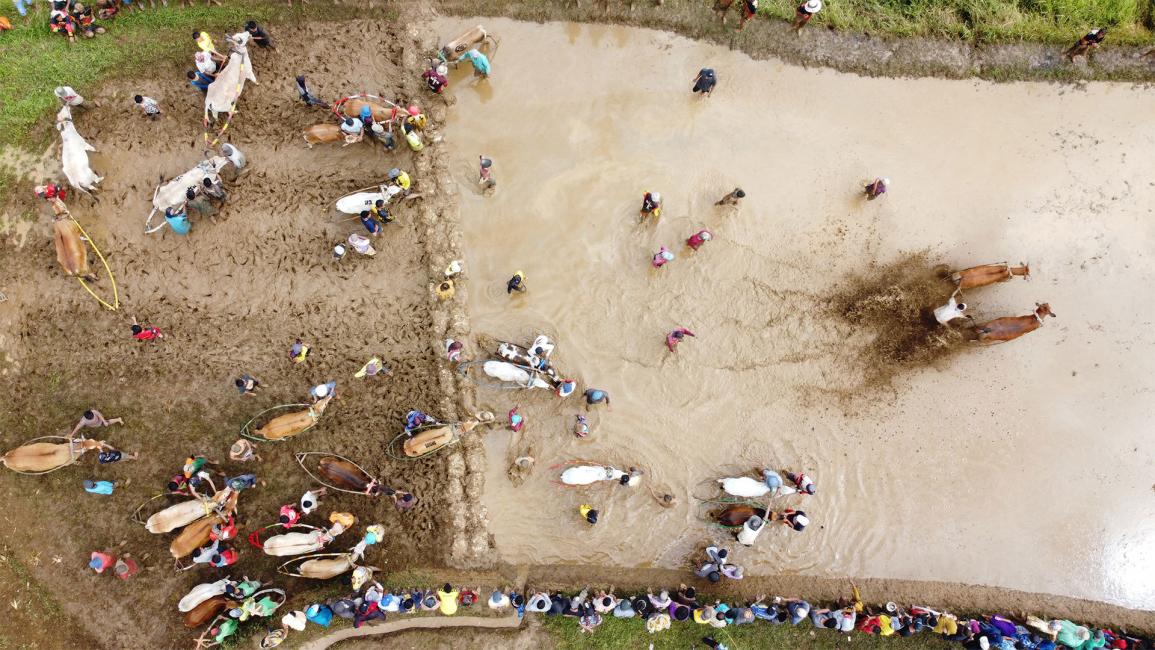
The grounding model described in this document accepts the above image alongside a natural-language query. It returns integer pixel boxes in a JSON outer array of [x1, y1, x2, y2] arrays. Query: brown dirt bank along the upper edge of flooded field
[[438, 0, 1155, 81]]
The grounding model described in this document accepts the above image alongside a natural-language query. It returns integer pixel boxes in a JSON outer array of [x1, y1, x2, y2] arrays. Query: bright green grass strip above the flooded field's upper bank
[[760, 0, 1155, 45]]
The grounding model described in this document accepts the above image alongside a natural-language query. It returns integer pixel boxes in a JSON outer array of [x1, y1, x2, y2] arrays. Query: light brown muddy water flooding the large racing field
[[438, 18, 1155, 608]]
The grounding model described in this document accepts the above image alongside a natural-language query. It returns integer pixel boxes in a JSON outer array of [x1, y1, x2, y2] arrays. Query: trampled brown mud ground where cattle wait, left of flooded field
[[0, 6, 489, 648]]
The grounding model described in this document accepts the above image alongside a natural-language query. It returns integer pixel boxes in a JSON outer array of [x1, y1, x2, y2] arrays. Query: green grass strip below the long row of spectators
[[540, 614, 957, 650]]
